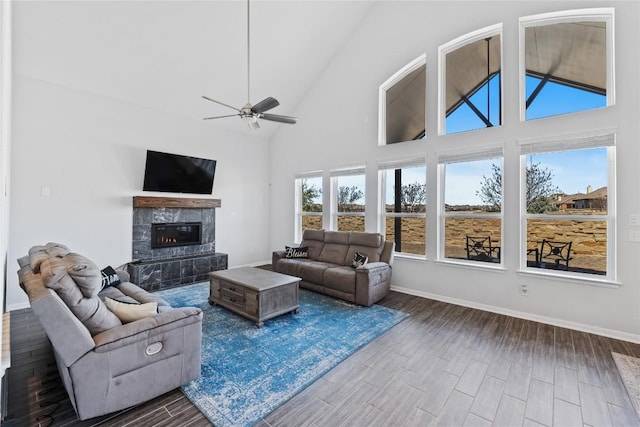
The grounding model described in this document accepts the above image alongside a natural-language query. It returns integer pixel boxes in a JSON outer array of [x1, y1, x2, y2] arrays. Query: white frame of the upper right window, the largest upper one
[[518, 7, 616, 122]]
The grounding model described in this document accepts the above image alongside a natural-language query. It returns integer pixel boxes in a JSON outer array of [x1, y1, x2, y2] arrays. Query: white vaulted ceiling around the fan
[[13, 0, 374, 137]]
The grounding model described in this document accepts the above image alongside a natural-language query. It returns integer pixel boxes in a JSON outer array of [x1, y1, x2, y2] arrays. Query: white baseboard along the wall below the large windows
[[391, 286, 640, 344]]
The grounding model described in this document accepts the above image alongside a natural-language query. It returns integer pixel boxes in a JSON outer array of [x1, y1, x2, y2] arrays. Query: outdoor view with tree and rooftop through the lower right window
[[525, 147, 609, 275]]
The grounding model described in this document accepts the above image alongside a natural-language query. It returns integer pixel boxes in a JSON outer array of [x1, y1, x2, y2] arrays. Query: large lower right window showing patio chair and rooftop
[[521, 133, 615, 279]]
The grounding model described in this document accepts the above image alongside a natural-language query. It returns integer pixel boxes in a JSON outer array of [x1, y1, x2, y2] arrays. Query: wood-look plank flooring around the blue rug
[[5, 292, 640, 427]]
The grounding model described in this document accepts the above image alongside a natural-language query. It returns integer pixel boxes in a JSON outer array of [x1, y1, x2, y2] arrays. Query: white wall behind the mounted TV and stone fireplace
[[7, 76, 270, 308]]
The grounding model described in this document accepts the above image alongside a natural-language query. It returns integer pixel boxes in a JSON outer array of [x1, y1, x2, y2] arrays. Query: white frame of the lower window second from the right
[[436, 145, 506, 269]]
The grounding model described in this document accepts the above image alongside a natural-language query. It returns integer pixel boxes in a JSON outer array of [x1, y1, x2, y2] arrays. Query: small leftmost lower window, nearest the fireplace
[[296, 175, 322, 242]]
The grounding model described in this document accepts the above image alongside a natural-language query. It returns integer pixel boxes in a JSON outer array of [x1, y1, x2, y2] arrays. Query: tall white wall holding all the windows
[[271, 1, 640, 341]]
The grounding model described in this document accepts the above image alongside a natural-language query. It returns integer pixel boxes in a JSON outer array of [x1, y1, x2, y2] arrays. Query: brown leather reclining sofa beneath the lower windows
[[272, 229, 395, 307]]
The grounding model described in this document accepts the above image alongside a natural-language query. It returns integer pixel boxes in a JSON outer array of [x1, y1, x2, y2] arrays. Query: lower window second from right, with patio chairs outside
[[439, 148, 502, 264]]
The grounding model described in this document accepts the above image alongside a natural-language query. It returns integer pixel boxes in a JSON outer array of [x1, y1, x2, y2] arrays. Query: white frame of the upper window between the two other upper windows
[[438, 23, 504, 136]]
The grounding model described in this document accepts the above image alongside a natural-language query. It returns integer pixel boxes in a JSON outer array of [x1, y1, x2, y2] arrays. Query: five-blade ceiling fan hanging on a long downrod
[[203, 0, 298, 130]]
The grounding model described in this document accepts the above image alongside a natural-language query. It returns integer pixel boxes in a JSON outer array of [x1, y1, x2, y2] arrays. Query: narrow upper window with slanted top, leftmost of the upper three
[[378, 55, 427, 145]]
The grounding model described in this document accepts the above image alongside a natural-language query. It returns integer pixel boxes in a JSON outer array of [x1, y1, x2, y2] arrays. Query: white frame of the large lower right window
[[518, 129, 617, 284]]
